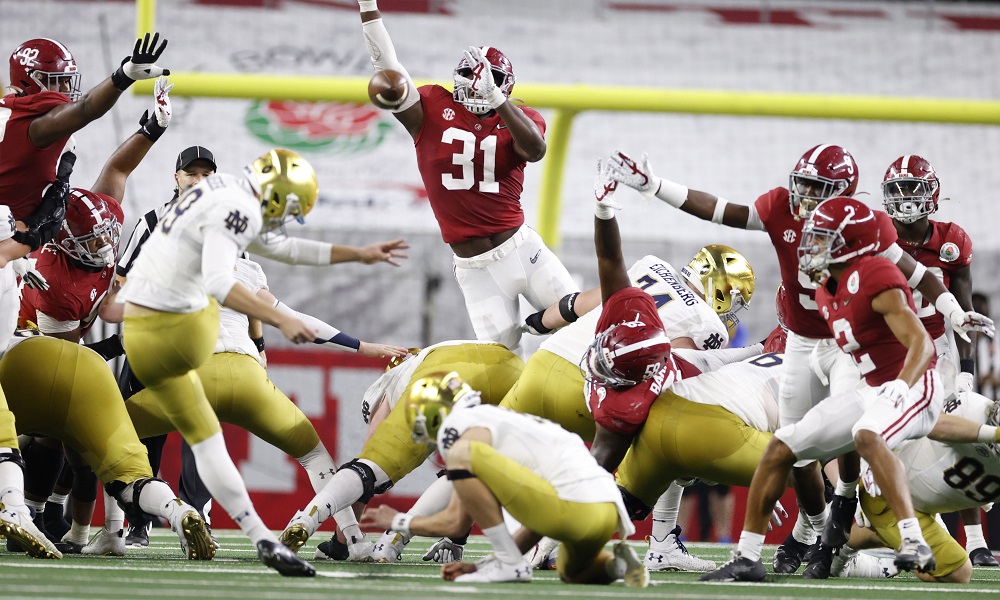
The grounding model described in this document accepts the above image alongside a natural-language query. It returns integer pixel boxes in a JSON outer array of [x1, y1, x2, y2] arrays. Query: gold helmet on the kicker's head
[[244, 148, 319, 232]]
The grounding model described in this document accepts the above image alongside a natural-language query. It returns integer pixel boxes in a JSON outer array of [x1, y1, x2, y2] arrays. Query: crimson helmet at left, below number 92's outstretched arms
[[52, 188, 125, 268]]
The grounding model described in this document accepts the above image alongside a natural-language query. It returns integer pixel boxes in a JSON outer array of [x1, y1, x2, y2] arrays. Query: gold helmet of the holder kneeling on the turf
[[406, 371, 478, 445]]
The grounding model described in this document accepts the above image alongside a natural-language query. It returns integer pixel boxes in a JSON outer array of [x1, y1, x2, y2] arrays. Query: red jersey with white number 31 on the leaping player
[[414, 85, 545, 244]]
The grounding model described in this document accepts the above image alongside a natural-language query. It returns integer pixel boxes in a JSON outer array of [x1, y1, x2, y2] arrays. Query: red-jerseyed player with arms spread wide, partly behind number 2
[[611, 144, 993, 573]]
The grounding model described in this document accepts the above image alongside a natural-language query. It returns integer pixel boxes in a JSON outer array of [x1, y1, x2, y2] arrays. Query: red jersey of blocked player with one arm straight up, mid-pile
[[584, 287, 680, 435]]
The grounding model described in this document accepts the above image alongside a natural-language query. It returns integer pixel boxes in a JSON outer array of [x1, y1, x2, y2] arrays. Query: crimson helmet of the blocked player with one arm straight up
[[583, 313, 670, 388]]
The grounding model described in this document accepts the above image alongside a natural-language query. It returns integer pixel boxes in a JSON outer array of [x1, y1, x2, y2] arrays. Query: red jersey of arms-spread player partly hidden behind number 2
[[754, 188, 897, 339]]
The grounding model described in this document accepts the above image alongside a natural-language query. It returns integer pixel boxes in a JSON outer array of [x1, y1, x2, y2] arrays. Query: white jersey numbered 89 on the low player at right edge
[[897, 393, 1000, 514]]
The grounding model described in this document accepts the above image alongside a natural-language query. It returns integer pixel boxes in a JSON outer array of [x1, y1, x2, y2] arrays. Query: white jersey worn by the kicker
[[121, 173, 263, 313]]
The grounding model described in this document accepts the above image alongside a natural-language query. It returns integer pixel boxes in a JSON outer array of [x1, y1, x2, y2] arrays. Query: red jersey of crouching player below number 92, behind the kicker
[[19, 245, 115, 337]]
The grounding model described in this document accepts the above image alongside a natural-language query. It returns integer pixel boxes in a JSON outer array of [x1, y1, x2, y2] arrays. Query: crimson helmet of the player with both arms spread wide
[[788, 144, 858, 219]]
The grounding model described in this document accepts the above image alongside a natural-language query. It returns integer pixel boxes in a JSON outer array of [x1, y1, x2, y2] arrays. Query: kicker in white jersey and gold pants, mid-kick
[[119, 149, 378, 576]]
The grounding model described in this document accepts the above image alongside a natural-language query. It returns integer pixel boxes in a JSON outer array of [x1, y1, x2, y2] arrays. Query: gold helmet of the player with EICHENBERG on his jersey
[[681, 244, 756, 327]]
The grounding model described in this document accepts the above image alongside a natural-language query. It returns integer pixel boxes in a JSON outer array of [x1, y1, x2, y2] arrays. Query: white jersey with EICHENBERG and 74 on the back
[[541, 256, 729, 364]]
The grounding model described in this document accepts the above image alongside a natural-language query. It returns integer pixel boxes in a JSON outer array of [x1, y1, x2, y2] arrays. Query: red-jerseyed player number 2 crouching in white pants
[[702, 197, 943, 581]]
